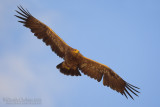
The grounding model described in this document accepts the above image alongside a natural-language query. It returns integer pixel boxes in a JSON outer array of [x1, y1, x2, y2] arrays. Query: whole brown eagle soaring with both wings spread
[[15, 6, 140, 100]]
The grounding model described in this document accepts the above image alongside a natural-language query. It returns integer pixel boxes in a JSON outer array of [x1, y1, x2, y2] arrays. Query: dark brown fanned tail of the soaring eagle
[[56, 62, 81, 76]]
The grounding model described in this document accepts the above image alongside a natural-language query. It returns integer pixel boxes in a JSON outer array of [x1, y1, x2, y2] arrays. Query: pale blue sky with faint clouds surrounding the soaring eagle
[[0, 0, 160, 107]]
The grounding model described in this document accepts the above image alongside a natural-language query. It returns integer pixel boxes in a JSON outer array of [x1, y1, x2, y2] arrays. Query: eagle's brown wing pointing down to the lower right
[[79, 56, 139, 99]]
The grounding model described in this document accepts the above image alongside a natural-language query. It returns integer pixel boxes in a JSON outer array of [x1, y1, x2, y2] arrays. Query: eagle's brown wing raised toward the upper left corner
[[15, 6, 70, 58]]
